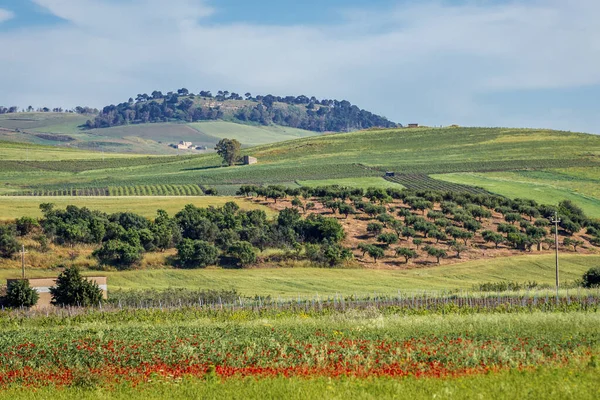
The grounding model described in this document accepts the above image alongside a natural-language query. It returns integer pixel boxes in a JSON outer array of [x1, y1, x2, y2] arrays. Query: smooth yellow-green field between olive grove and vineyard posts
[[0, 253, 600, 297]]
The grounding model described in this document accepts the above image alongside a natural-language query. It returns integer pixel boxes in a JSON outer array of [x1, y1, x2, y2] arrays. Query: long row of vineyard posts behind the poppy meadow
[[2, 290, 600, 317]]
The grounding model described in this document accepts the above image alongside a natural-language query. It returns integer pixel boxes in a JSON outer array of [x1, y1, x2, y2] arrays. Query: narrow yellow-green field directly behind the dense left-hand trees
[[0, 196, 273, 220]]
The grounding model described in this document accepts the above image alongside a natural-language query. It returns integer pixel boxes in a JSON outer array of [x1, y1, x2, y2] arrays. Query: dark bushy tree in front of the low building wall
[[50, 266, 102, 307]]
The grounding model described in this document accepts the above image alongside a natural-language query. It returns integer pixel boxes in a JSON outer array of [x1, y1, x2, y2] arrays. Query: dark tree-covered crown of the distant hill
[[86, 88, 398, 132]]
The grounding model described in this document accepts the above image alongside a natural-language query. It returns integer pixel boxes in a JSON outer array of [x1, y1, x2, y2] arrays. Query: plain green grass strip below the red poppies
[[0, 368, 600, 400]]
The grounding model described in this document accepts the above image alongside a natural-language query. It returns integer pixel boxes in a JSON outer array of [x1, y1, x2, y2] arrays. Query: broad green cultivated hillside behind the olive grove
[[0, 128, 600, 217]]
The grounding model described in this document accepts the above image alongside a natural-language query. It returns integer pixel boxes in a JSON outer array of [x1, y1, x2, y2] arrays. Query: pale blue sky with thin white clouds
[[0, 0, 600, 134]]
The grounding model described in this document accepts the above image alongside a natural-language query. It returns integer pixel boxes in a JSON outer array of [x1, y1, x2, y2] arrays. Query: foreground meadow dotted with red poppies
[[0, 308, 600, 399]]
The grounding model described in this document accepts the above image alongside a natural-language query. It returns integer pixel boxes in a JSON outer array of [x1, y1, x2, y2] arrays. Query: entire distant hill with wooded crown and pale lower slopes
[[0, 89, 398, 155]]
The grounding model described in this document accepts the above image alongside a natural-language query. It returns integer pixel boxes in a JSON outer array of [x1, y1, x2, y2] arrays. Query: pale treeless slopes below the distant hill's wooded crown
[[0, 113, 318, 155]]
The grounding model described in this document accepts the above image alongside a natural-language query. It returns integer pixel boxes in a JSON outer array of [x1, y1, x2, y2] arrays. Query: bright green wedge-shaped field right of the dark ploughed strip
[[432, 168, 600, 218]]
